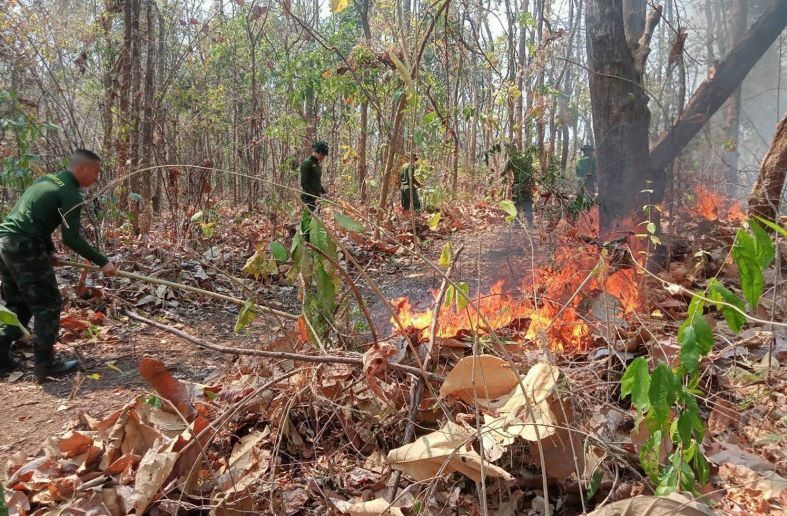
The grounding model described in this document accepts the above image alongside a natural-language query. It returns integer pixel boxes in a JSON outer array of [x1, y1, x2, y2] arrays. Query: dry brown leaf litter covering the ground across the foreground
[[0, 204, 787, 514]]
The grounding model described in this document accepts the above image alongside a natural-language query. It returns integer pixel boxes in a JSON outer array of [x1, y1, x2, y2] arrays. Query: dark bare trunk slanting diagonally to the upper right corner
[[650, 0, 787, 176]]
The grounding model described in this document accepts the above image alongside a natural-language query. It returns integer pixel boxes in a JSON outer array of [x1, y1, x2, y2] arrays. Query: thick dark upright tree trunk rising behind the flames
[[586, 0, 652, 235]]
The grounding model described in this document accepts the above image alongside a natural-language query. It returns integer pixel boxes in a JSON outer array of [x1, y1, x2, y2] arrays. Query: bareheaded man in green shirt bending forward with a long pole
[[0, 149, 117, 381]]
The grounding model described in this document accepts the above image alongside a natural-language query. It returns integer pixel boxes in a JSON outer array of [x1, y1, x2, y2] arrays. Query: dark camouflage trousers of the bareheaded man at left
[[0, 236, 63, 363]]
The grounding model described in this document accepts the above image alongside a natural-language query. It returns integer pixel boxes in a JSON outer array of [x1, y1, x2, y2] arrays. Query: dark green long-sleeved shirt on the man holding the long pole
[[0, 170, 109, 267]]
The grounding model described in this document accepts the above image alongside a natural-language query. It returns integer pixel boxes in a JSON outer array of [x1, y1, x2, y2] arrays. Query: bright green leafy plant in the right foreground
[[621, 220, 778, 496]]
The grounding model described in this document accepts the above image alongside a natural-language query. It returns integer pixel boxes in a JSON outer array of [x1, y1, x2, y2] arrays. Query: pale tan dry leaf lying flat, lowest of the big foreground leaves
[[387, 422, 513, 482]]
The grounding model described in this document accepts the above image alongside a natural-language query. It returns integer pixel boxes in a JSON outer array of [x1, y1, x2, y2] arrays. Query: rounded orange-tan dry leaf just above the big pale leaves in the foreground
[[440, 355, 519, 405]]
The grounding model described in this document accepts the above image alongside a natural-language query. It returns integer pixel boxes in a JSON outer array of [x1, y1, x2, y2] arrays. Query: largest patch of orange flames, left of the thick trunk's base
[[392, 208, 643, 352]]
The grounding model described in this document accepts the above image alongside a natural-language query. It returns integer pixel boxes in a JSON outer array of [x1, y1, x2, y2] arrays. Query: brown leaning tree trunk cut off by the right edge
[[749, 113, 787, 220]]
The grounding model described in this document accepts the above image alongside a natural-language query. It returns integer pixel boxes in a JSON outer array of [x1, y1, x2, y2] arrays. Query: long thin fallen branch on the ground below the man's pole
[[123, 310, 445, 382]]
